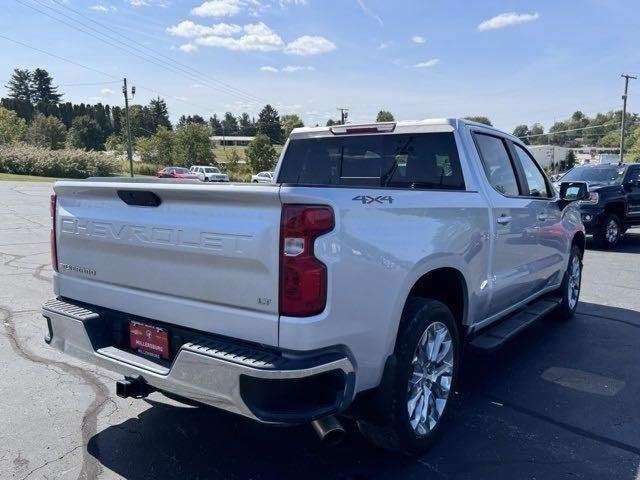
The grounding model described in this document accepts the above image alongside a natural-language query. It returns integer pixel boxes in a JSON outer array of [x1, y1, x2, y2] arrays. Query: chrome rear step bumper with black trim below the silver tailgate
[[42, 299, 355, 424]]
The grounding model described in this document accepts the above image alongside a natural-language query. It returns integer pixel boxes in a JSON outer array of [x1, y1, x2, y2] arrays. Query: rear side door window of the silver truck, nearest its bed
[[474, 133, 520, 197]]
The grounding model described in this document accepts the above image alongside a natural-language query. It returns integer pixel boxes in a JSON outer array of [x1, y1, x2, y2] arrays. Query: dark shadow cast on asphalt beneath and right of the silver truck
[[87, 303, 640, 480]]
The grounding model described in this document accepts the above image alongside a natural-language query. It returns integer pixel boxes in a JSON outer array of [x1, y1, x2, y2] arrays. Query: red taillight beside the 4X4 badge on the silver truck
[[280, 205, 334, 317]]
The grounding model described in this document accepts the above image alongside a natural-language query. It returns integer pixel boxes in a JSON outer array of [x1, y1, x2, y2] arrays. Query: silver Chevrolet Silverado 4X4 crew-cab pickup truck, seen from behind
[[42, 119, 588, 453]]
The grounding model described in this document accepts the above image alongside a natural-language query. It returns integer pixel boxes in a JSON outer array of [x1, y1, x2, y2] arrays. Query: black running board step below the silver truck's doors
[[469, 297, 562, 352]]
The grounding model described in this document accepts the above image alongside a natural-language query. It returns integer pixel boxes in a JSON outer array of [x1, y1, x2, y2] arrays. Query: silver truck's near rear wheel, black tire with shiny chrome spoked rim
[[358, 298, 460, 455]]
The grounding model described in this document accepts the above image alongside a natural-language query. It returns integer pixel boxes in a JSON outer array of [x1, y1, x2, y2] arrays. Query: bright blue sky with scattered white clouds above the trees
[[0, 0, 640, 130]]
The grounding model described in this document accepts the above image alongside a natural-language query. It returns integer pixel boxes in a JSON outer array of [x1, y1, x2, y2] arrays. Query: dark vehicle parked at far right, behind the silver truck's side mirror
[[559, 164, 640, 248]]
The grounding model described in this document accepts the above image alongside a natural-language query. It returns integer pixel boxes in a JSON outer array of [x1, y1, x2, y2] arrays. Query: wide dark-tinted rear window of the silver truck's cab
[[278, 133, 465, 190]]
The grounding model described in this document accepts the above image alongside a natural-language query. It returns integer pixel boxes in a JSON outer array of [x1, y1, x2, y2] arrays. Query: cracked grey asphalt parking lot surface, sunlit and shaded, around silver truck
[[0, 182, 640, 480]]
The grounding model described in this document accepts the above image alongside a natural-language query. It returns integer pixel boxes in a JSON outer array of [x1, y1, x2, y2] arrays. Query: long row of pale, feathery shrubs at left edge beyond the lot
[[0, 144, 120, 178]]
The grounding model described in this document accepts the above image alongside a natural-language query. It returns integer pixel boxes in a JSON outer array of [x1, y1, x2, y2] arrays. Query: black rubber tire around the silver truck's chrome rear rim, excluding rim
[[358, 297, 461, 455]]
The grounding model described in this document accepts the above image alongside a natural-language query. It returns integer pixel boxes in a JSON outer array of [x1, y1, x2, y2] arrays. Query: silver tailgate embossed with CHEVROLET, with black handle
[[54, 181, 281, 345]]
